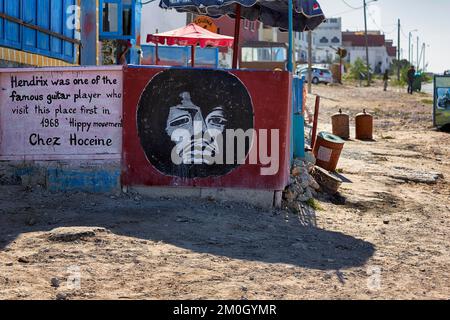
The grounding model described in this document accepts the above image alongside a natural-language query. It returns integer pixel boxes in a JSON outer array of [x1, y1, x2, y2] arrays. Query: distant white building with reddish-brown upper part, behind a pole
[[342, 31, 397, 73]]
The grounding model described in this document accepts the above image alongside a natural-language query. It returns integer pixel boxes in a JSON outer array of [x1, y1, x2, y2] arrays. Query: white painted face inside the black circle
[[166, 92, 227, 164]]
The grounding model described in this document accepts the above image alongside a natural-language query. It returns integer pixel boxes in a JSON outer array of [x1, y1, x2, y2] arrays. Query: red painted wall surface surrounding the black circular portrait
[[122, 67, 291, 190]]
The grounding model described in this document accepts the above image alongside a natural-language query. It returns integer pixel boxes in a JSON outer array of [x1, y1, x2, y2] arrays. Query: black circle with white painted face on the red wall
[[137, 69, 253, 178]]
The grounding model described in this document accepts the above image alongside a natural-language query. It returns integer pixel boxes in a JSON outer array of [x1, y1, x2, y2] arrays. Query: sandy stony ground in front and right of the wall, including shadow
[[0, 80, 450, 299]]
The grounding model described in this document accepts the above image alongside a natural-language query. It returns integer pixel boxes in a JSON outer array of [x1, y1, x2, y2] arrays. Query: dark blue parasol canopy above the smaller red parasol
[[159, 0, 325, 32]]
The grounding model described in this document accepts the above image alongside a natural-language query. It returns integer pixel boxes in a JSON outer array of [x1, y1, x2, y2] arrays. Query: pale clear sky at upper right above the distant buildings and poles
[[318, 0, 450, 73]]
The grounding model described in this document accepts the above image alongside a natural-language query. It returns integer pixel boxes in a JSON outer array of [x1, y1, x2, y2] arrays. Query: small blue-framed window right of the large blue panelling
[[100, 0, 136, 40]]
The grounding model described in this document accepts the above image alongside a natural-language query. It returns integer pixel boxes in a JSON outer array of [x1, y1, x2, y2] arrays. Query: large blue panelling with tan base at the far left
[[0, 0, 80, 66]]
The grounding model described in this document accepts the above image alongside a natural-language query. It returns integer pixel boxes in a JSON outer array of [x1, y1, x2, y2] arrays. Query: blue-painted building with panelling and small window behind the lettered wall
[[0, 0, 142, 67]]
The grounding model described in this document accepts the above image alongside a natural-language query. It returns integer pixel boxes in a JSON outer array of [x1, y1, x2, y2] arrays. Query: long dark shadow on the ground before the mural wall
[[0, 188, 375, 270]]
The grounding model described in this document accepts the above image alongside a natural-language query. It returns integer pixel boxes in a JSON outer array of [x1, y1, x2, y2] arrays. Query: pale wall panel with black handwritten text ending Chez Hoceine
[[0, 67, 122, 160]]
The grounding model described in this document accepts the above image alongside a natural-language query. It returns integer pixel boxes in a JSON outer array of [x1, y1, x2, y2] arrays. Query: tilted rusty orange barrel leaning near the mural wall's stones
[[313, 132, 345, 171]]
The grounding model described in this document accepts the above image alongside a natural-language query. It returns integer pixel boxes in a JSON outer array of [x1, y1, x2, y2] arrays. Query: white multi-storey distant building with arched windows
[[313, 18, 342, 63]]
